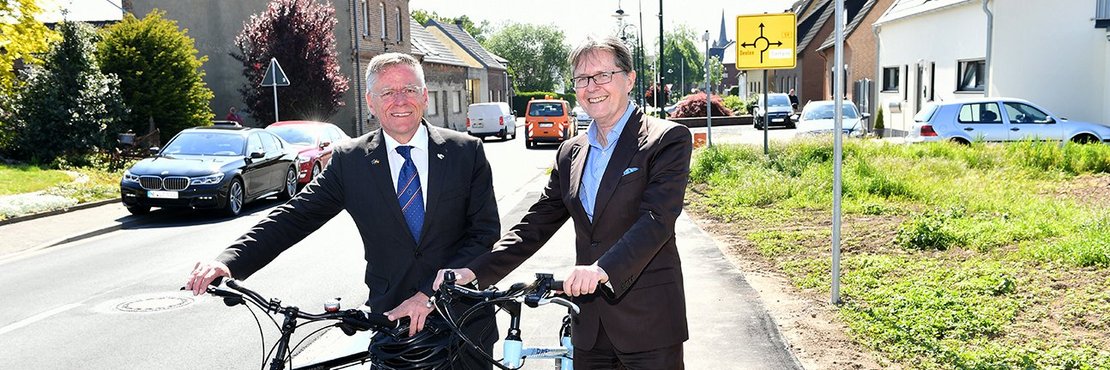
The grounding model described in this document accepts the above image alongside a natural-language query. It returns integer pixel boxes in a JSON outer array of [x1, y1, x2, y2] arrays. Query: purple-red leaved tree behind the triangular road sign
[[231, 0, 349, 124]]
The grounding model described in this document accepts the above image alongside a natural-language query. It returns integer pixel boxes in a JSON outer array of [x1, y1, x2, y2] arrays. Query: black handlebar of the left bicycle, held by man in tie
[[208, 279, 401, 334]]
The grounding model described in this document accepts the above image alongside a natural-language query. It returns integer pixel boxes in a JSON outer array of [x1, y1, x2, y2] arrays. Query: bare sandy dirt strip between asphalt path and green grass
[[686, 204, 898, 369]]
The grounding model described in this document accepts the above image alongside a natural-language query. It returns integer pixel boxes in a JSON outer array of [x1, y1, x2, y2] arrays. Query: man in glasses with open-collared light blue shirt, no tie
[[435, 38, 692, 369]]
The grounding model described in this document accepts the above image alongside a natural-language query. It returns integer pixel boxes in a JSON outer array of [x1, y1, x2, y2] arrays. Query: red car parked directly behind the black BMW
[[266, 121, 351, 188]]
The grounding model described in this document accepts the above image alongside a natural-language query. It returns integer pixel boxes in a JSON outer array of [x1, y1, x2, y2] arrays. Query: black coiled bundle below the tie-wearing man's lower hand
[[370, 316, 462, 370]]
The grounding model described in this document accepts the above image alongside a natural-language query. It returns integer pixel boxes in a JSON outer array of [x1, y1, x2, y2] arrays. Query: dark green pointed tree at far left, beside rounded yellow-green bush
[[16, 22, 127, 164]]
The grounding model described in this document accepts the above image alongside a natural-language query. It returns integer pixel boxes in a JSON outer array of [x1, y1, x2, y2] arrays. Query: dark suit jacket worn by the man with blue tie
[[218, 122, 501, 312]]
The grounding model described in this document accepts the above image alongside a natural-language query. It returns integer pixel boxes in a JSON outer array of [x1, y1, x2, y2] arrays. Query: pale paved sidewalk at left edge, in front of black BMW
[[0, 202, 139, 260]]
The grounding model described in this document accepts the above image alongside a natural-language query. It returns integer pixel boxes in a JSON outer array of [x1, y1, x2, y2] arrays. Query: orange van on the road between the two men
[[524, 99, 578, 149]]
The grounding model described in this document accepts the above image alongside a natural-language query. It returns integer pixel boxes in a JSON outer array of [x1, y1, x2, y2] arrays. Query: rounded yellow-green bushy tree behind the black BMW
[[97, 10, 212, 142]]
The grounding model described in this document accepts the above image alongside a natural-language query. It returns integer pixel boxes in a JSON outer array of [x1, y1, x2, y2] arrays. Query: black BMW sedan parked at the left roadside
[[120, 126, 296, 216]]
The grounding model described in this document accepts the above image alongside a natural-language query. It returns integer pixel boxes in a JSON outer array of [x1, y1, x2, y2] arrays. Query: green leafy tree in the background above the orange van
[[482, 23, 571, 91]]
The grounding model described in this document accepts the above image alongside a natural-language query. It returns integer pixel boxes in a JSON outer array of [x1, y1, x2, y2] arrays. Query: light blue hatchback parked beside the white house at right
[[906, 98, 1110, 143]]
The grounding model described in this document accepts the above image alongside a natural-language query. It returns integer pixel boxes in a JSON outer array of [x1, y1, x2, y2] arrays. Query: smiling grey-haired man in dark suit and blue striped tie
[[186, 53, 501, 369]]
